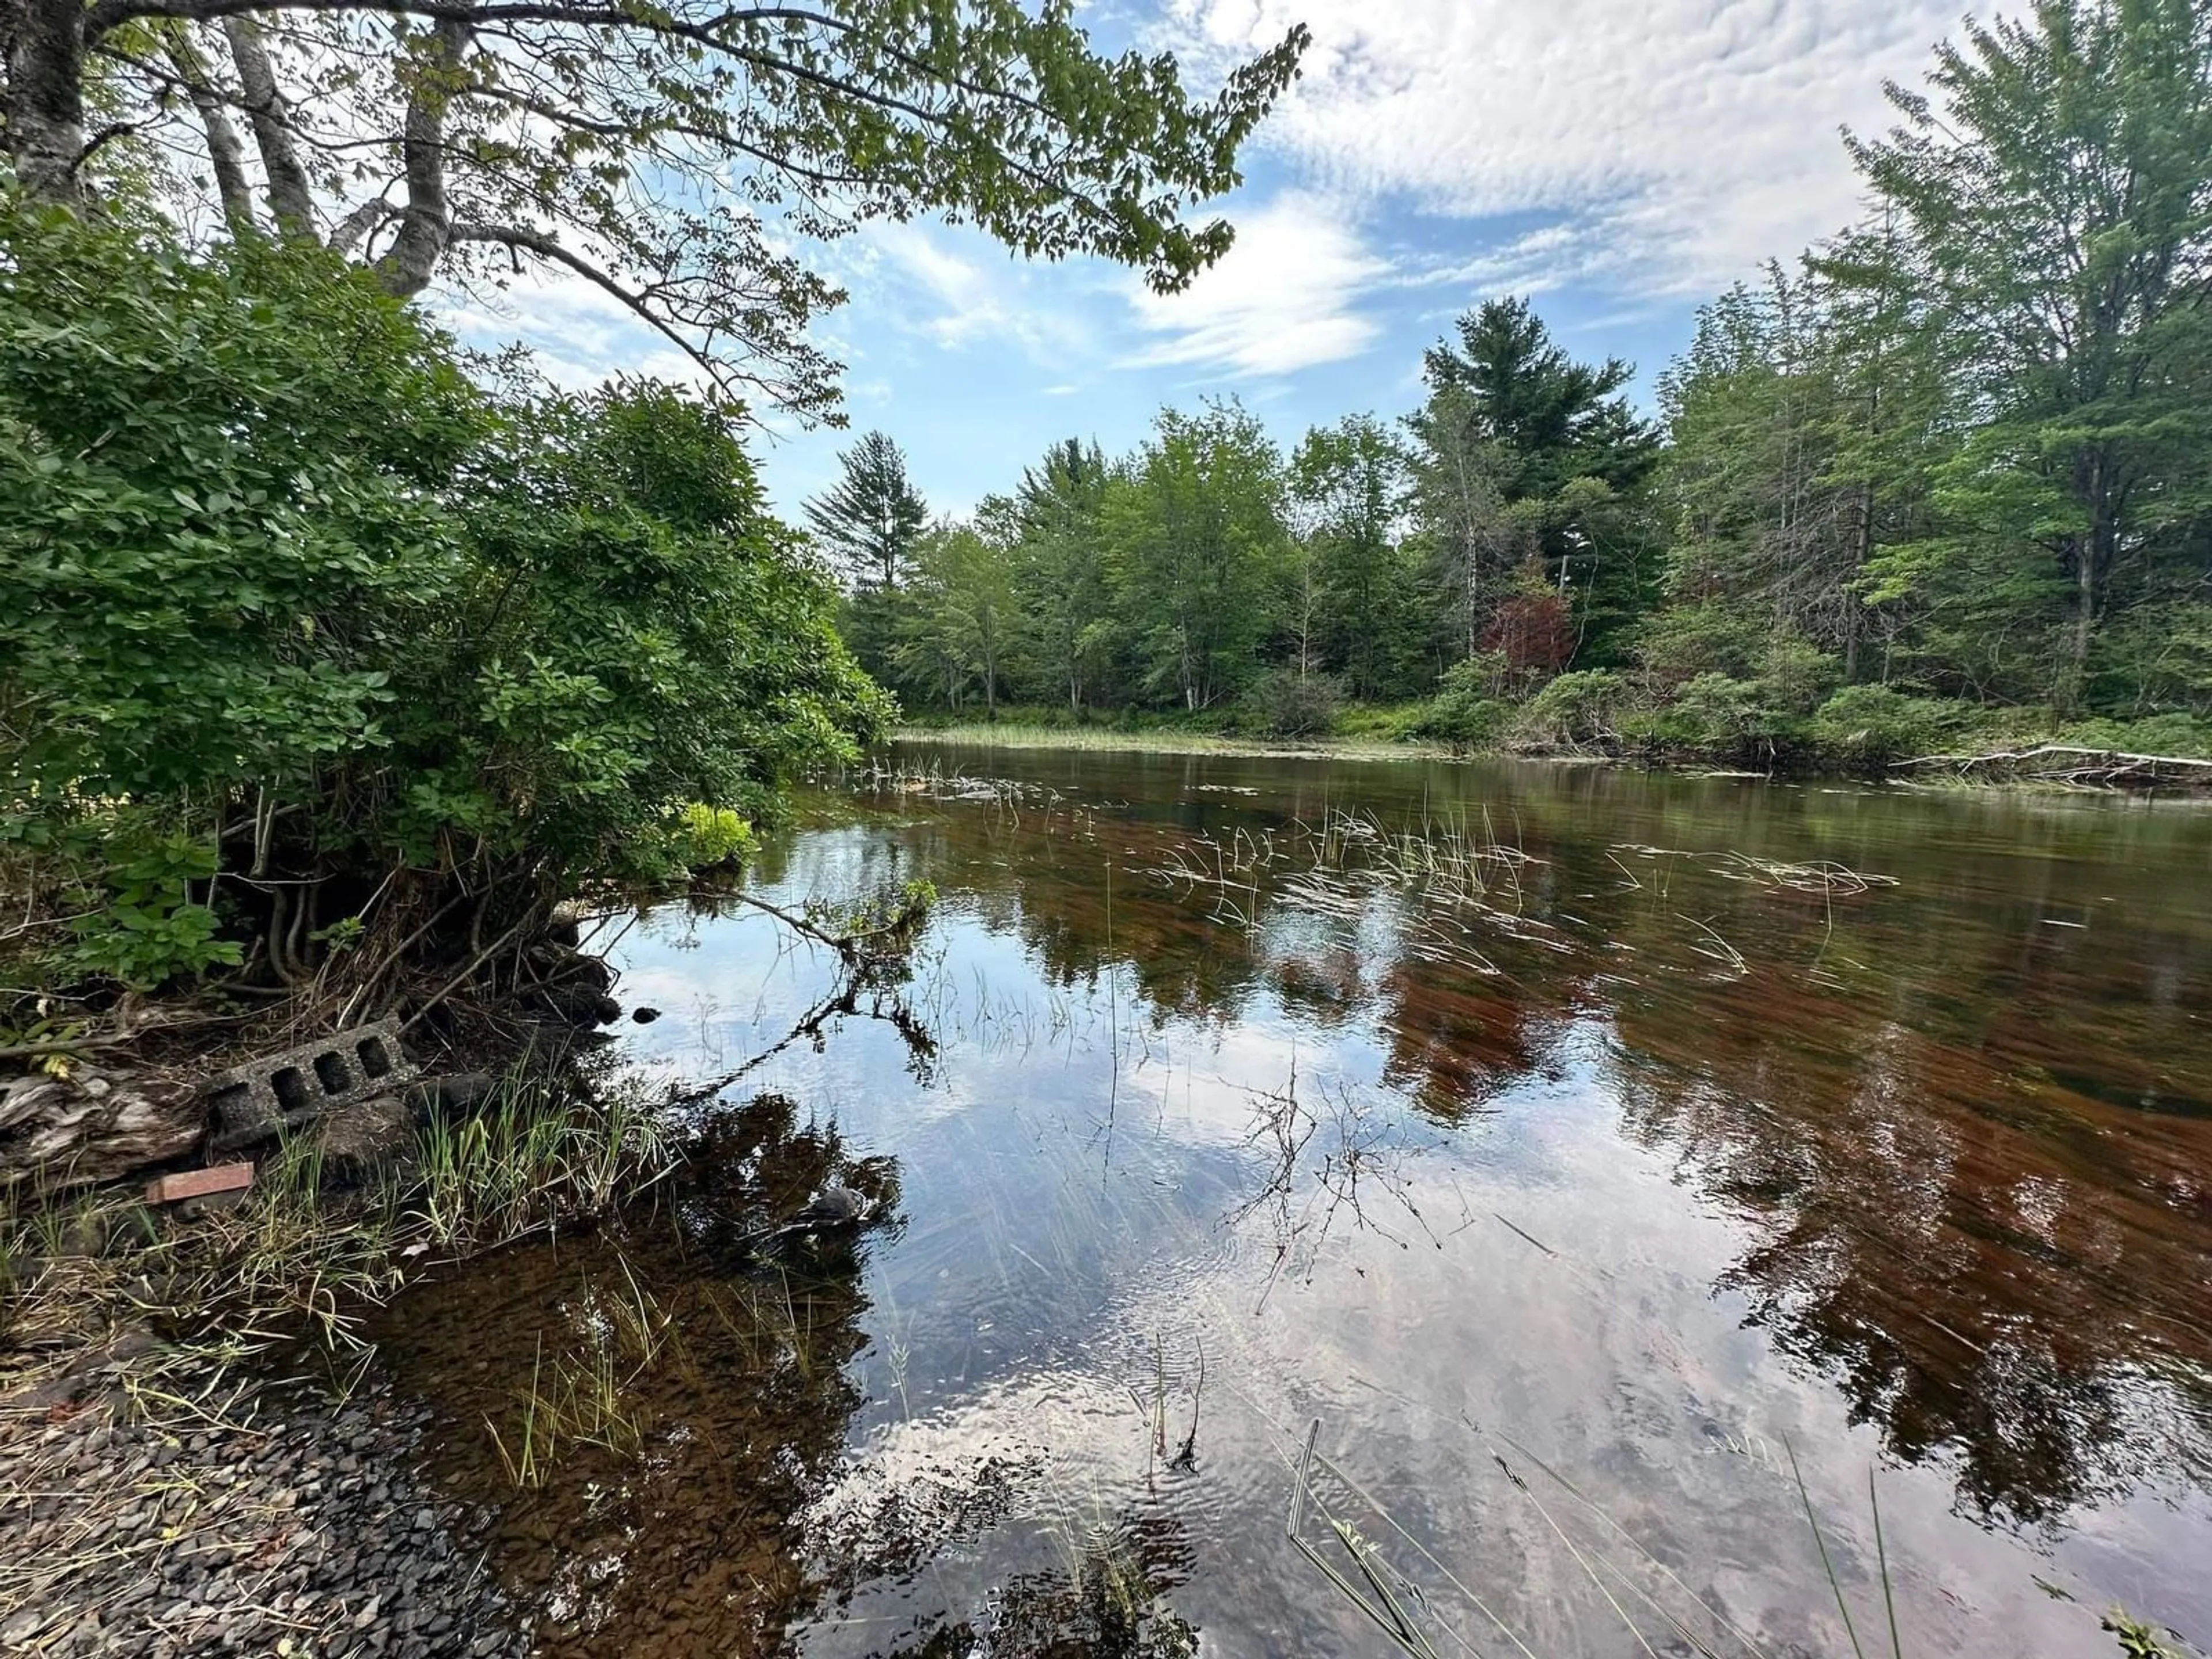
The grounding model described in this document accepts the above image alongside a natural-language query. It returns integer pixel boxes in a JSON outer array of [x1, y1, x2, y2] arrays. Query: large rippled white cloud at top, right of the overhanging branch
[[1164, 0, 1962, 292]]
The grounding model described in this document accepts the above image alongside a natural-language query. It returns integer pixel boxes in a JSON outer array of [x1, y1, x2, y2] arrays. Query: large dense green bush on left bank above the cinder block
[[0, 203, 885, 984]]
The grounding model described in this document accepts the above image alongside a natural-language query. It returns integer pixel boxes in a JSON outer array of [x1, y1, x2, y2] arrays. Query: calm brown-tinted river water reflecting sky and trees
[[380, 750, 2212, 1659]]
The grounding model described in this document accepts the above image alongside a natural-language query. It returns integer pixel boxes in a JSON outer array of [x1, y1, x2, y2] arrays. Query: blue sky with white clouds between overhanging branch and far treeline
[[447, 0, 1960, 513]]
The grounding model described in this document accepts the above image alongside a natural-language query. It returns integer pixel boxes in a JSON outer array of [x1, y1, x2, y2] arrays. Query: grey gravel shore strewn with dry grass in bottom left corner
[[0, 1345, 533, 1659]]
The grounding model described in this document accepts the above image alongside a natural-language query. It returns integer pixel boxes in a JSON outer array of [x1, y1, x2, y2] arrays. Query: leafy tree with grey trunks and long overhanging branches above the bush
[[0, 0, 1307, 414]]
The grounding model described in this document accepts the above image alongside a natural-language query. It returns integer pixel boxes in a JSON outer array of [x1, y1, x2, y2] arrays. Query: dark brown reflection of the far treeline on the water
[[823, 754, 2212, 1522]]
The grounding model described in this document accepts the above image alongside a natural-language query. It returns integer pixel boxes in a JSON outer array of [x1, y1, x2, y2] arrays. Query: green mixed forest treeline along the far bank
[[809, 0, 2212, 763]]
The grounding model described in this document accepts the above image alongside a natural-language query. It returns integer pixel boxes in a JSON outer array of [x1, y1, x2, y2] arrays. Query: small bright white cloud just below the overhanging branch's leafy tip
[[1130, 192, 1391, 376]]
